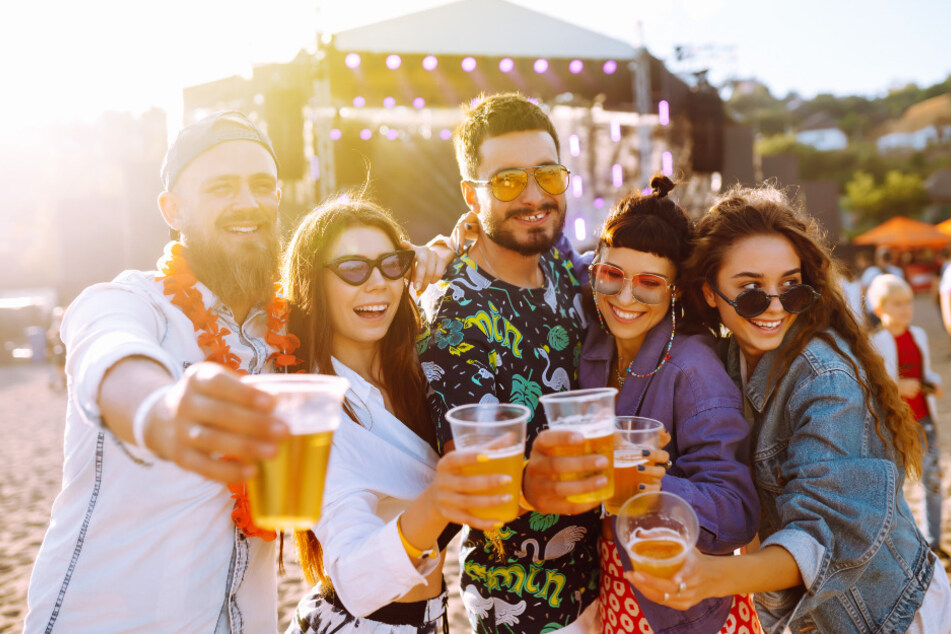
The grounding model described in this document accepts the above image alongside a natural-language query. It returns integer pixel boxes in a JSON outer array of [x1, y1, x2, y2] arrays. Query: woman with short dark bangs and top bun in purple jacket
[[579, 176, 759, 634]]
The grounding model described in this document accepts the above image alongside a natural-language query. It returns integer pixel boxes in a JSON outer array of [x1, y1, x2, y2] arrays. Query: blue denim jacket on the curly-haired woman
[[726, 328, 934, 634]]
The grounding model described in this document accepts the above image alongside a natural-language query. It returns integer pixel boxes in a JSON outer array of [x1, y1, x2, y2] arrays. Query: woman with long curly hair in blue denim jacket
[[629, 180, 951, 634]]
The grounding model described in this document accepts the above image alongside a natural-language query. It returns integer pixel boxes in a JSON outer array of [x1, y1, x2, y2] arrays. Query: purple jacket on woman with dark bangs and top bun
[[578, 315, 759, 634]]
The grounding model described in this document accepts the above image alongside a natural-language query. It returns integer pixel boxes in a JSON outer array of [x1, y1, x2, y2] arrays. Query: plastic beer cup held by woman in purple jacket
[[604, 416, 664, 515]]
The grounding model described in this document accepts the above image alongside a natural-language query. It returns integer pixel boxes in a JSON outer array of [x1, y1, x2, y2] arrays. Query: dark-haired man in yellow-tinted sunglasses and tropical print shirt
[[421, 94, 604, 634]]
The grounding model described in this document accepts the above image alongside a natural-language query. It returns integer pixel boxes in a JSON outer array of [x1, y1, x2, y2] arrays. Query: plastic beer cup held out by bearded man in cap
[[244, 374, 350, 531]]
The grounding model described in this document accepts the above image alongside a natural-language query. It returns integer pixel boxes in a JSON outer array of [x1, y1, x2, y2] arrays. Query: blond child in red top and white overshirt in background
[[868, 274, 951, 563]]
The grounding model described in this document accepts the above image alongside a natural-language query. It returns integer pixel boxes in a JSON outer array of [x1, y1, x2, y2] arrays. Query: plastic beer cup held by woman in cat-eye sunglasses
[[446, 403, 531, 522]]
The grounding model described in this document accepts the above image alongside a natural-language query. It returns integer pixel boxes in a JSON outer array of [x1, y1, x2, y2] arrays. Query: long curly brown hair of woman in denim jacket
[[684, 185, 923, 476]]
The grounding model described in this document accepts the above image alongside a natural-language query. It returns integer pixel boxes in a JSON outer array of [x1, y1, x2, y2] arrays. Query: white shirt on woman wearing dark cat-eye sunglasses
[[314, 359, 439, 616]]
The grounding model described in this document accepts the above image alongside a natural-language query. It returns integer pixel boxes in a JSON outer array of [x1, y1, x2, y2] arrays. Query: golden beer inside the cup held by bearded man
[[248, 429, 333, 531]]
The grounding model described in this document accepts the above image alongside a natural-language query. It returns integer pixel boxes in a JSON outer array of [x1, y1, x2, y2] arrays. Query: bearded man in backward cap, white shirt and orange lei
[[25, 112, 294, 633]]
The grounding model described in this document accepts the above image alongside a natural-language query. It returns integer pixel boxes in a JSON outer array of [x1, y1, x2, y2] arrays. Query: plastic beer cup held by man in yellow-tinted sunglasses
[[538, 387, 617, 504]]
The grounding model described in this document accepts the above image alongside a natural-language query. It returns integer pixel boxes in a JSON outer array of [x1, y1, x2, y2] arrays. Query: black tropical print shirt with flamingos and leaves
[[420, 249, 600, 633]]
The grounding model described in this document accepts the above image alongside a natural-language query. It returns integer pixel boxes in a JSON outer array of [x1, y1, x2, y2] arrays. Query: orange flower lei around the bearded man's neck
[[155, 242, 301, 541]]
